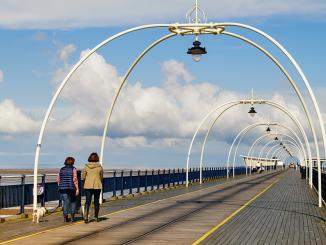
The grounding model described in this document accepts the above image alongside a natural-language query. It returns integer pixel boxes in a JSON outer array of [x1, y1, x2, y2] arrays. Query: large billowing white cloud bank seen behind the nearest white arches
[[51, 47, 290, 147]]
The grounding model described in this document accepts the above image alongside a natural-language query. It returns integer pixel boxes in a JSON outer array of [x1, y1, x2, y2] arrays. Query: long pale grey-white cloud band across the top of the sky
[[0, 0, 326, 29]]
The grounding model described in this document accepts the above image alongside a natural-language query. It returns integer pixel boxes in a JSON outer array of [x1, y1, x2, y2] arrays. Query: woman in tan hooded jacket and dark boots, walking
[[82, 152, 103, 224]]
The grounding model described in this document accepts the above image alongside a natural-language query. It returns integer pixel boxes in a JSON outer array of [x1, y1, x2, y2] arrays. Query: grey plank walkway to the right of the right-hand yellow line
[[202, 170, 326, 245]]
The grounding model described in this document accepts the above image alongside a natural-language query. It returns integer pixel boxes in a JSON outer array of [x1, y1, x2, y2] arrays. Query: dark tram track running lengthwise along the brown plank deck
[[60, 172, 282, 244]]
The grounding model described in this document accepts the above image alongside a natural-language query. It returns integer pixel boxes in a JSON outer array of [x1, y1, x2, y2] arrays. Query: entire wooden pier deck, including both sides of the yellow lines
[[0, 170, 326, 245]]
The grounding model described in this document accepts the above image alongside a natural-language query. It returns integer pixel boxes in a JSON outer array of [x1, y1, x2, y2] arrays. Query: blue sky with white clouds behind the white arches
[[0, 0, 326, 168]]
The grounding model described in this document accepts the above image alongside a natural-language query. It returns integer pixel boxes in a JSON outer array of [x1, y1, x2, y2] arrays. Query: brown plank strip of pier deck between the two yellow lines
[[0, 172, 285, 245]]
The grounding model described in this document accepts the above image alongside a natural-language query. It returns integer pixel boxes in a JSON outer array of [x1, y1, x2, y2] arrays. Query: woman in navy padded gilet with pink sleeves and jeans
[[57, 157, 79, 222]]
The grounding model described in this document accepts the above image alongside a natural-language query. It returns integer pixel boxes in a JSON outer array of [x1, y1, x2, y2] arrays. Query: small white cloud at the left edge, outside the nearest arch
[[0, 99, 39, 134]]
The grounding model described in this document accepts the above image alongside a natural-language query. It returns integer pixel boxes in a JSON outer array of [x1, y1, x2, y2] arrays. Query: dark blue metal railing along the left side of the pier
[[0, 167, 246, 213]]
